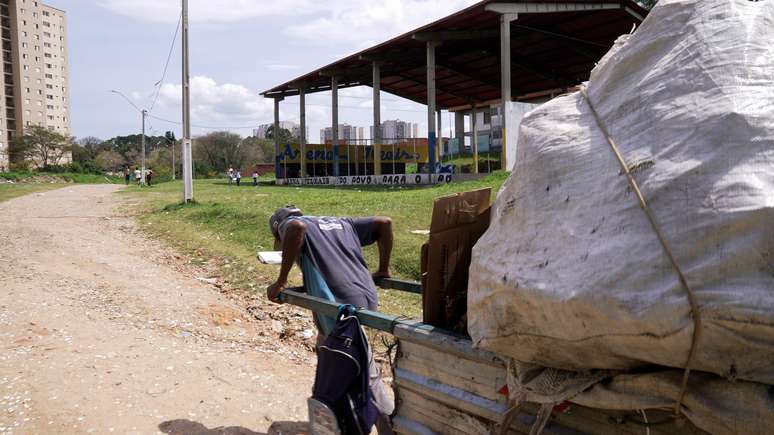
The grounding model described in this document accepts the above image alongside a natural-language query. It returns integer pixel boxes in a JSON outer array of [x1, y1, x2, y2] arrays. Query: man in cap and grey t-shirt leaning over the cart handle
[[267, 206, 395, 434]]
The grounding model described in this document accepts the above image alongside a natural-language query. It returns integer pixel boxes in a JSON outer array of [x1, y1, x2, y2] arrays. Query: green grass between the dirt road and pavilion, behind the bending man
[[124, 173, 507, 316]]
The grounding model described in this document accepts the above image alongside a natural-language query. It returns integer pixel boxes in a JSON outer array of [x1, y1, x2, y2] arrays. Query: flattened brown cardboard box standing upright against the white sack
[[421, 188, 492, 334]]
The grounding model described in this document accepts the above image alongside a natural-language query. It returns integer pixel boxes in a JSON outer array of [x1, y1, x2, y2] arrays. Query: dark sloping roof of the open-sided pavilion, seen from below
[[262, 0, 648, 109]]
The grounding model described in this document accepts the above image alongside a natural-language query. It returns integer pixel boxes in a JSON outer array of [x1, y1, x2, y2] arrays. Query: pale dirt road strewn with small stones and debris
[[0, 185, 314, 435]]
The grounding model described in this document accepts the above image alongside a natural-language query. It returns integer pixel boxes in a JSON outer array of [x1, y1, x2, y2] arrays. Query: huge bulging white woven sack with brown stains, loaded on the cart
[[468, 0, 774, 384]]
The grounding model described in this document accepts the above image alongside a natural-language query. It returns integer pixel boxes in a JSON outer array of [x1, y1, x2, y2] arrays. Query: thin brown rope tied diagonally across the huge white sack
[[580, 85, 702, 417]]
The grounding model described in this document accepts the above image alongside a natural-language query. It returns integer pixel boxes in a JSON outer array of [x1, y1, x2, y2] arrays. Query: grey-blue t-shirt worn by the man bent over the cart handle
[[279, 216, 378, 310]]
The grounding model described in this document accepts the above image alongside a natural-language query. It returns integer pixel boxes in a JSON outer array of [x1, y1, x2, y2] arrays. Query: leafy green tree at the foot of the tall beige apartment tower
[[12, 125, 73, 168]]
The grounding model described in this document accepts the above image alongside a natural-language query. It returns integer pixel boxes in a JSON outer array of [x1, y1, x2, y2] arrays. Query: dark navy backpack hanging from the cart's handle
[[312, 305, 379, 435]]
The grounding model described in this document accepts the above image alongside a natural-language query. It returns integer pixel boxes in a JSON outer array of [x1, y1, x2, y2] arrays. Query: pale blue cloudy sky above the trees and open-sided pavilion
[[56, 0, 476, 142]]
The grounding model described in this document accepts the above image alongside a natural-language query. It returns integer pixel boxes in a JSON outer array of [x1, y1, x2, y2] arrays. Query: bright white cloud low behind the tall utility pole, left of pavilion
[[159, 76, 274, 130]]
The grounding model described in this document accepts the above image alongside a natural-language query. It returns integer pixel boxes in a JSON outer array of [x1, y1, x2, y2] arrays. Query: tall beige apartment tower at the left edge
[[0, 0, 70, 170]]
